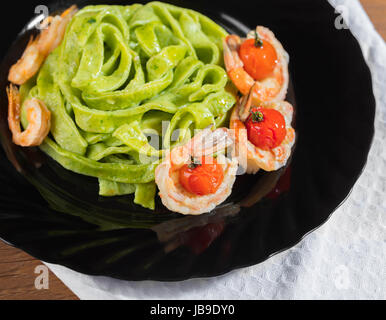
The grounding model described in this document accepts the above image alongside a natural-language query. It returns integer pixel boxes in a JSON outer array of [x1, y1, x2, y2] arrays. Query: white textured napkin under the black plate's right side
[[43, 0, 386, 300]]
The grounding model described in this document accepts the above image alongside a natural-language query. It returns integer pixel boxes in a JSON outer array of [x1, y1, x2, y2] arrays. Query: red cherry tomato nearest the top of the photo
[[239, 39, 277, 81]]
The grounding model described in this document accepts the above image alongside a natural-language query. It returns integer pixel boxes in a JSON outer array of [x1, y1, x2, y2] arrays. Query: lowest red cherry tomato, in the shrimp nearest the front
[[179, 157, 224, 196]]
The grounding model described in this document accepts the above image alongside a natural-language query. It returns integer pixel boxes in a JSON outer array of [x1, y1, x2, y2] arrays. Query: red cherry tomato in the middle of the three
[[245, 107, 287, 150]]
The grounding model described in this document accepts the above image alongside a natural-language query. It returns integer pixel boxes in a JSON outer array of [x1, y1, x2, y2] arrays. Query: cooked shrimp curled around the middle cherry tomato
[[230, 83, 295, 174]]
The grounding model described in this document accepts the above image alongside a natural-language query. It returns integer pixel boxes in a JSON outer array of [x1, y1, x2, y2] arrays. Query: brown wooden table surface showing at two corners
[[0, 0, 386, 300]]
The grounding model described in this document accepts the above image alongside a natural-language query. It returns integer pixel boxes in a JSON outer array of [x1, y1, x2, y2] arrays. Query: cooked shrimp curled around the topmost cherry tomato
[[223, 26, 289, 103]]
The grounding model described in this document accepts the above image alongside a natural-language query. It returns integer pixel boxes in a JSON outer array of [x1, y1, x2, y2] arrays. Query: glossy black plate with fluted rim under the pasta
[[0, 0, 375, 280]]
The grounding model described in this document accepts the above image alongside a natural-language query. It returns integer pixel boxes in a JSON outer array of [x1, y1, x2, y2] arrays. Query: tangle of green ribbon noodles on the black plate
[[21, 2, 235, 209]]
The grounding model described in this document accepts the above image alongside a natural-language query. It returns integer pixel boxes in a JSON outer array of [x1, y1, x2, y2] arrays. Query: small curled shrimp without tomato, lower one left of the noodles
[[7, 85, 51, 147]]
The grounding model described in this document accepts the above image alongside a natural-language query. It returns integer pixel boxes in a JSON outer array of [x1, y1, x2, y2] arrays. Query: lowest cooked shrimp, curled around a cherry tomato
[[155, 128, 238, 215]]
